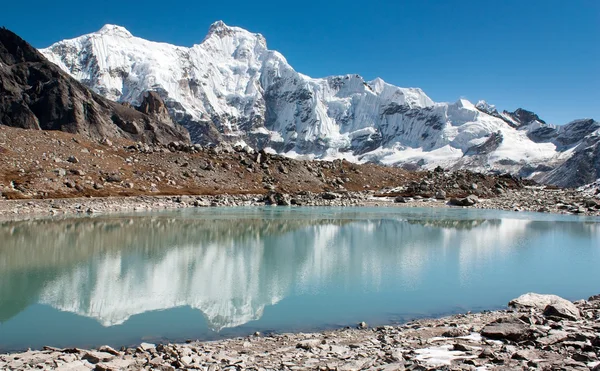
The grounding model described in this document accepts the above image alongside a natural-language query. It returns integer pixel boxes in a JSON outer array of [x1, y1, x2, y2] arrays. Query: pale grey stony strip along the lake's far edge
[[0, 187, 600, 222]]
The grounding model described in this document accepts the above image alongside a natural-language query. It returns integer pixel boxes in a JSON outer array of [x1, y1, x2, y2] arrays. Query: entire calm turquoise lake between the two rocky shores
[[0, 207, 600, 350]]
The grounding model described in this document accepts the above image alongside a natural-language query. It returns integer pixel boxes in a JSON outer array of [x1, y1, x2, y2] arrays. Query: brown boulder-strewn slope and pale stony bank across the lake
[[0, 125, 600, 219]]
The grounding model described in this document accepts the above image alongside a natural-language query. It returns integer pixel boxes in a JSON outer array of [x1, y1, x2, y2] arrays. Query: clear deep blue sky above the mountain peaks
[[0, 0, 600, 124]]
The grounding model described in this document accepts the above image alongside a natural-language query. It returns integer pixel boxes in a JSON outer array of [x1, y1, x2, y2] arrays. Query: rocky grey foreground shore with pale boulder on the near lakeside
[[0, 294, 600, 371]]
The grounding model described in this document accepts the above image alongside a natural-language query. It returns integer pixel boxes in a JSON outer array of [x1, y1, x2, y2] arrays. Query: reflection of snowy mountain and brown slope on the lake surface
[[0, 208, 600, 352]]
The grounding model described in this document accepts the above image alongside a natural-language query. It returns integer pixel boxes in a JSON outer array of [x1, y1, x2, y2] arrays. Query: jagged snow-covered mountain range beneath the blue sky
[[42, 21, 600, 185]]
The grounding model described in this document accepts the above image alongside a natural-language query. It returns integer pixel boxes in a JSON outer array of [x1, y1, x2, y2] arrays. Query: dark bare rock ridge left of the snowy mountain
[[0, 28, 189, 144]]
